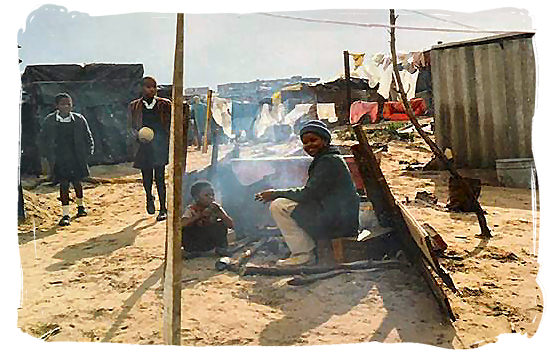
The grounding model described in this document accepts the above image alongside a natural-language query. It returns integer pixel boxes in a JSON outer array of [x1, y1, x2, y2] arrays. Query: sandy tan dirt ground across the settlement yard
[[18, 134, 543, 348]]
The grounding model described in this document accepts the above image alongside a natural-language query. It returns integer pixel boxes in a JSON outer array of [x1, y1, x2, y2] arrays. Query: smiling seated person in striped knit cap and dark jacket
[[256, 120, 360, 266]]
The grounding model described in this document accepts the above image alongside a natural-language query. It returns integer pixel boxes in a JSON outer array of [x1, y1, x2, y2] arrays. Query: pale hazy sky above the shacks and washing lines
[[18, 5, 536, 88]]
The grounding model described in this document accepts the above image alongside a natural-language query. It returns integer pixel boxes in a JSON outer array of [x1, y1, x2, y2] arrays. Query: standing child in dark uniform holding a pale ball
[[128, 77, 172, 221]]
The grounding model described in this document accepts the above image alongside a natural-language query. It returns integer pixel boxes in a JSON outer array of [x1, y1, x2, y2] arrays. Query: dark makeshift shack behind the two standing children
[[21, 64, 143, 174]]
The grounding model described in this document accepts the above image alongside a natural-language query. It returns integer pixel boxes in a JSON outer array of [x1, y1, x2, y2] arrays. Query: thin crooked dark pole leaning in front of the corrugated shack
[[390, 10, 492, 238]]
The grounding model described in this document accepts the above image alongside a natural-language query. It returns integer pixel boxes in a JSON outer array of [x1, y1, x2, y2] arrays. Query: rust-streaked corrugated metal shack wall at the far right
[[430, 34, 536, 168]]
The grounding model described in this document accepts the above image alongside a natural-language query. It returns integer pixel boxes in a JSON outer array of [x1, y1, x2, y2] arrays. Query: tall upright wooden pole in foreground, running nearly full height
[[162, 13, 187, 345]]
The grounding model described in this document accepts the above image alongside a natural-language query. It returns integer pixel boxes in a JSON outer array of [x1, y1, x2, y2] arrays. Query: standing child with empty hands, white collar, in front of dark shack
[[41, 93, 94, 226]]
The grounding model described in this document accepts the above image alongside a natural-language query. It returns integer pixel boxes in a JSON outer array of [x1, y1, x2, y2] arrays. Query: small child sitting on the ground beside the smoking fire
[[182, 181, 233, 255]]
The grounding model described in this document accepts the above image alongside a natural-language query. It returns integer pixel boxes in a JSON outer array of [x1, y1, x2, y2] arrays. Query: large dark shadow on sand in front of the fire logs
[[239, 269, 456, 348]]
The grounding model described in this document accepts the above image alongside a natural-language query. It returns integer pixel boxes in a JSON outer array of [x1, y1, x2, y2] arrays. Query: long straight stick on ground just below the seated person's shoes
[[241, 260, 403, 276]]
